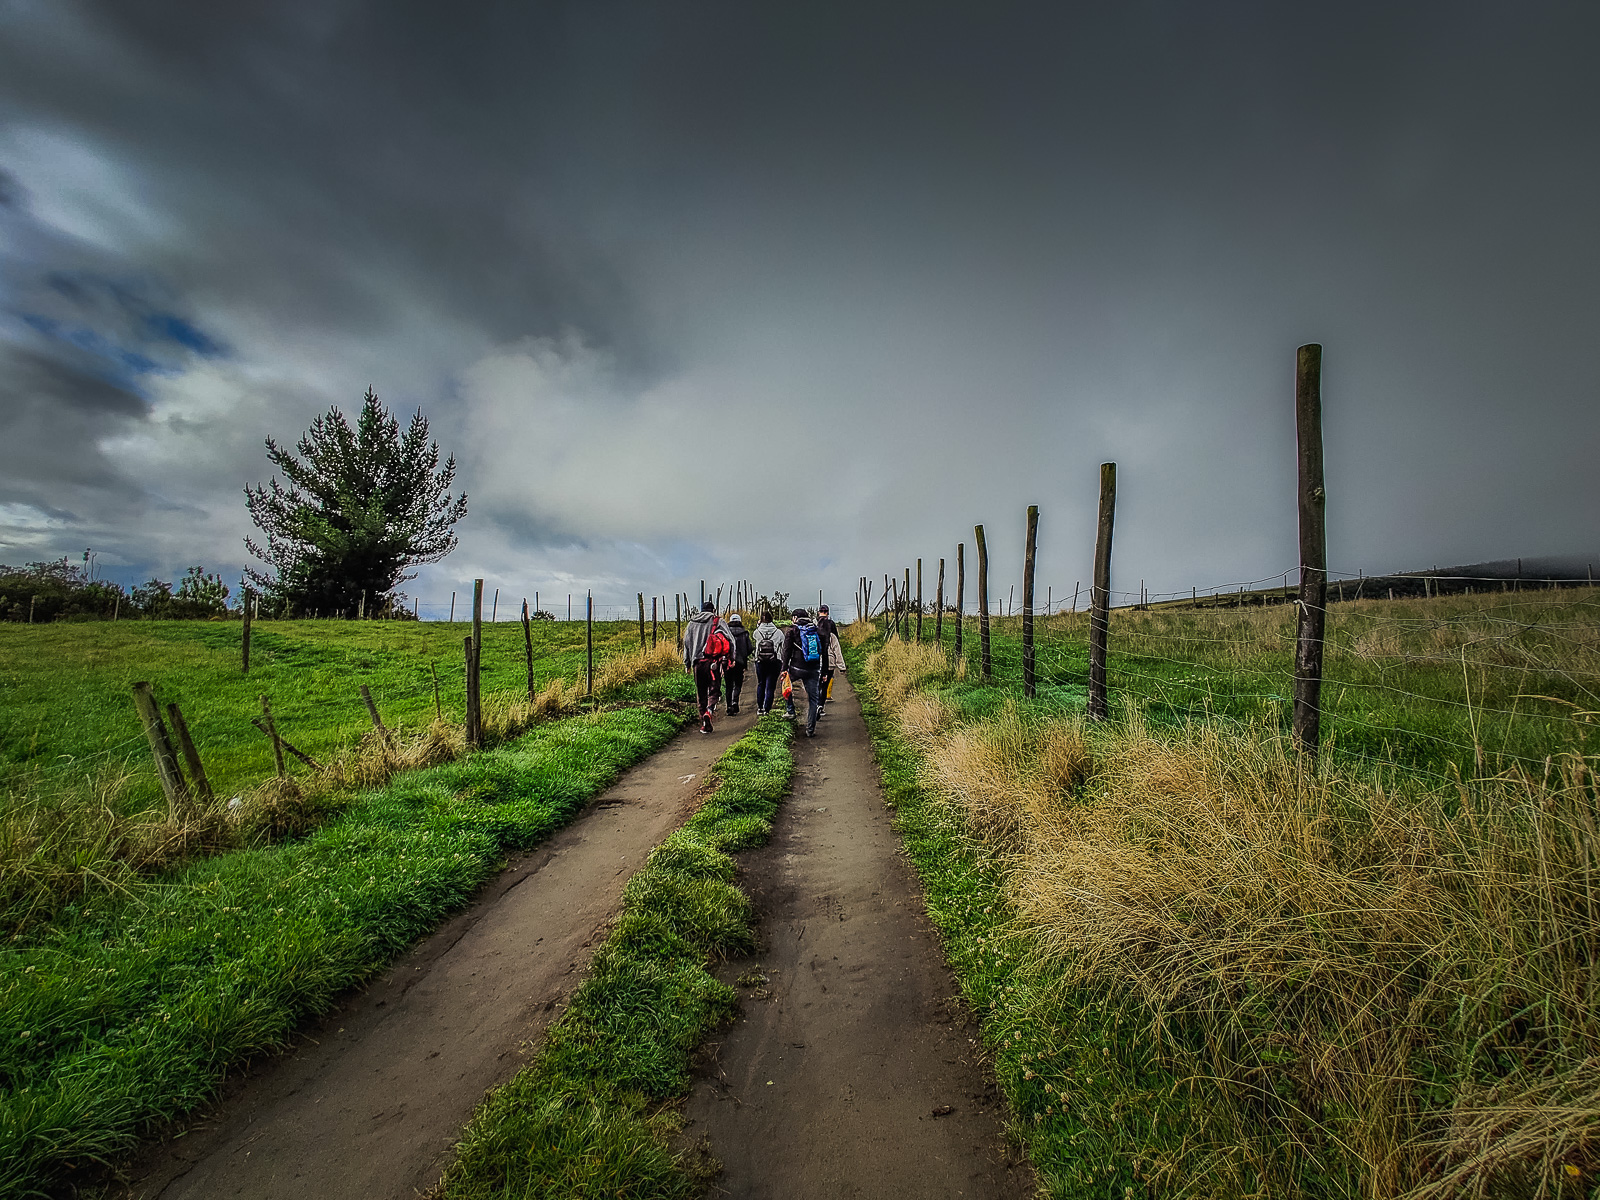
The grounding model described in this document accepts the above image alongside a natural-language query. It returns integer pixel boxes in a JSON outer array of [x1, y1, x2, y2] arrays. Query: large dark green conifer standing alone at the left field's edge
[[245, 387, 467, 618]]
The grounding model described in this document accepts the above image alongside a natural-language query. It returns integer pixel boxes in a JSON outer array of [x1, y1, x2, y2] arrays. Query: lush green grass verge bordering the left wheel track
[[0, 704, 685, 1197]]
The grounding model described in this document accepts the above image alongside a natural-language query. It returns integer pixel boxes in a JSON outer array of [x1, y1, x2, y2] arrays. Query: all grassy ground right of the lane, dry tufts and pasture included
[[851, 592, 1600, 1198]]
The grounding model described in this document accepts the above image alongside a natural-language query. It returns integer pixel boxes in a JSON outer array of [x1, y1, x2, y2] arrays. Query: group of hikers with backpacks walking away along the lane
[[683, 600, 845, 738]]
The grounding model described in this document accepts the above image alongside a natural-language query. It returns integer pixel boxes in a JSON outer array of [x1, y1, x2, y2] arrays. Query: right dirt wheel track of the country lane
[[685, 680, 1034, 1200]]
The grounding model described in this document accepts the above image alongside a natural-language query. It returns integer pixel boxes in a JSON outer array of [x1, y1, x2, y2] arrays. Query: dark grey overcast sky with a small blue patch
[[0, 0, 1600, 616]]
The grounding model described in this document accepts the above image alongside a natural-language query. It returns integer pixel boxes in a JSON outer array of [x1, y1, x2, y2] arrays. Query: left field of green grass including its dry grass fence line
[[0, 621, 675, 931]]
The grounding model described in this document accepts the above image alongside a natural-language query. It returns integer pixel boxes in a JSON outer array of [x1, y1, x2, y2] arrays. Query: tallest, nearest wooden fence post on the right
[[1294, 342, 1328, 760]]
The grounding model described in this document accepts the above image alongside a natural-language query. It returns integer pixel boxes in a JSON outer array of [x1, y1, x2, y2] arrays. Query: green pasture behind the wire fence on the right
[[923, 589, 1600, 776]]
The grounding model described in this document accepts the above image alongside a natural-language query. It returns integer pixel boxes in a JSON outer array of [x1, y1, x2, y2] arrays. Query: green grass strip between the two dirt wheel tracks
[[438, 717, 794, 1200]]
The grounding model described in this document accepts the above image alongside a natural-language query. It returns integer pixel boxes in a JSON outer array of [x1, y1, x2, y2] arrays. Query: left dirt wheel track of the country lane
[[122, 688, 755, 1200]]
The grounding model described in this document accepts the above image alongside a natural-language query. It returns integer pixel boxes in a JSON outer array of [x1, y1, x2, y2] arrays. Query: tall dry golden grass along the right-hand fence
[[870, 620, 1600, 1200]]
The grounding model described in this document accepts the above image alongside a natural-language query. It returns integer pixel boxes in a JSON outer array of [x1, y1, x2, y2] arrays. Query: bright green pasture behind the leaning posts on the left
[[0, 621, 670, 811]]
